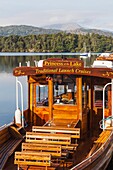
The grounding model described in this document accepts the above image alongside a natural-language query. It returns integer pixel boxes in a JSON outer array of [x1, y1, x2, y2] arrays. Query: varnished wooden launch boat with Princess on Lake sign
[[0, 58, 113, 170]]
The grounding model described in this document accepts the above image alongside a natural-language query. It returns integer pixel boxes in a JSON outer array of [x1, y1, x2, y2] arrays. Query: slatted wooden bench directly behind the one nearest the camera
[[22, 143, 62, 157]]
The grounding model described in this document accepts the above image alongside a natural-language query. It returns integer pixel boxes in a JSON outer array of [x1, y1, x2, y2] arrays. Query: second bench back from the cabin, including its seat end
[[26, 132, 78, 152]]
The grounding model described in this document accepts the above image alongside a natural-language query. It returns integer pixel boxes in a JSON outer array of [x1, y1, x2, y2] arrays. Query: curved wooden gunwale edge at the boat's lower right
[[70, 131, 113, 170]]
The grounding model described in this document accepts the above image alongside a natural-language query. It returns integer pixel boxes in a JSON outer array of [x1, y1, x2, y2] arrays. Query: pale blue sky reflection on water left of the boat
[[0, 72, 27, 126]]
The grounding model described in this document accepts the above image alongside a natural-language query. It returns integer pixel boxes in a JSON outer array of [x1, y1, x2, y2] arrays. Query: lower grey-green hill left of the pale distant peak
[[0, 25, 61, 36]]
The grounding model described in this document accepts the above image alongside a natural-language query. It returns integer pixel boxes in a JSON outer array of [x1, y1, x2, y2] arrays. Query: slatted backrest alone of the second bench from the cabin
[[26, 132, 71, 145]]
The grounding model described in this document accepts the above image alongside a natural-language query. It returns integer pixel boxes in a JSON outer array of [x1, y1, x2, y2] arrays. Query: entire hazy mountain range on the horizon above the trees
[[0, 23, 113, 37]]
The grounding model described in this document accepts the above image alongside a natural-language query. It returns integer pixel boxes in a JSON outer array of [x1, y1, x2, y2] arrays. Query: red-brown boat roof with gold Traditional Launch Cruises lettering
[[13, 58, 113, 79]]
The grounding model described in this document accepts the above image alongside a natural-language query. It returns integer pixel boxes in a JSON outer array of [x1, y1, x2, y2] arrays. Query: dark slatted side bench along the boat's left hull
[[0, 127, 23, 169]]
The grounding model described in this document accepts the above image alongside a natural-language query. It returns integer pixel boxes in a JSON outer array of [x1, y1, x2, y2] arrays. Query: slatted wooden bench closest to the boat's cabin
[[32, 126, 80, 139]]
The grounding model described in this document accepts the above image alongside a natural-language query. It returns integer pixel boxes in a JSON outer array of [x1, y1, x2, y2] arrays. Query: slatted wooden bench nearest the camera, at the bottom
[[14, 152, 55, 170]]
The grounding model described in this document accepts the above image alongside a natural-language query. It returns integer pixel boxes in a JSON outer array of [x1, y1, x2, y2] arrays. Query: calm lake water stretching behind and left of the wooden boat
[[0, 53, 95, 126]]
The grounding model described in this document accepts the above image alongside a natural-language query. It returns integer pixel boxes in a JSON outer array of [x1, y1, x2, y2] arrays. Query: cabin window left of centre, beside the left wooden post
[[36, 85, 48, 106]]
